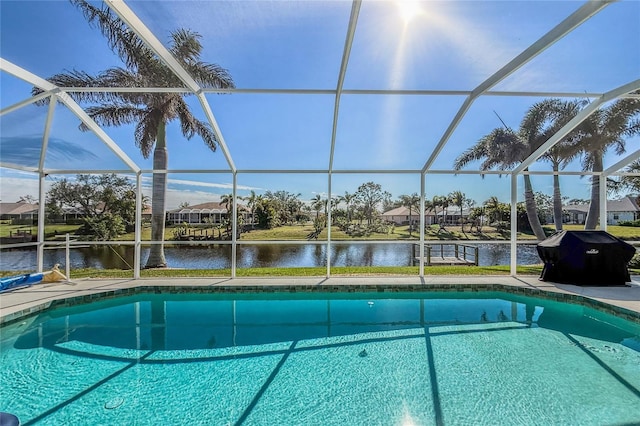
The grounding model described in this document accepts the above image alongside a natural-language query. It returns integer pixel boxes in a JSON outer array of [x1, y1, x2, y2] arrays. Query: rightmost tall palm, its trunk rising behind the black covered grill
[[572, 98, 640, 229]]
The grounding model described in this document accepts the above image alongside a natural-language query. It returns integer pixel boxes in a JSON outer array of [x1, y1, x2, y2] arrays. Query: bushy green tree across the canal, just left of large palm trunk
[[46, 174, 141, 241]]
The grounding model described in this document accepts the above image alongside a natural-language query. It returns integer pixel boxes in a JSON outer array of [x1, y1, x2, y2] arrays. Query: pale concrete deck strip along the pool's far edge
[[0, 275, 640, 324]]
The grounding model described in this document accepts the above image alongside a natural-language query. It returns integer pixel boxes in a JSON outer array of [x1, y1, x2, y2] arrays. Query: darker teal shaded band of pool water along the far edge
[[10, 294, 637, 350]]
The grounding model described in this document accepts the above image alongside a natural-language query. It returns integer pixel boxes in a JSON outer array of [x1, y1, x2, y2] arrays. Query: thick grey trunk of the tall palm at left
[[146, 123, 168, 268]]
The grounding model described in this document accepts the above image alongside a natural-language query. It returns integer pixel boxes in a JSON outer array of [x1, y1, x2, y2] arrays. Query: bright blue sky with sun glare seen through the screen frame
[[0, 0, 640, 207]]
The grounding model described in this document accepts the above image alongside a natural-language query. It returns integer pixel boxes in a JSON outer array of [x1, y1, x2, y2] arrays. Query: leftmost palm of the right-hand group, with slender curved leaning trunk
[[453, 101, 572, 240]]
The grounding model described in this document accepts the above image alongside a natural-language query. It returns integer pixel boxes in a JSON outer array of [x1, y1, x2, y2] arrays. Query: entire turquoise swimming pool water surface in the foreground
[[0, 293, 640, 425]]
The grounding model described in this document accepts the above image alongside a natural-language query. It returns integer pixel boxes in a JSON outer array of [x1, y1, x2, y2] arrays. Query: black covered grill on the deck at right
[[537, 231, 635, 286]]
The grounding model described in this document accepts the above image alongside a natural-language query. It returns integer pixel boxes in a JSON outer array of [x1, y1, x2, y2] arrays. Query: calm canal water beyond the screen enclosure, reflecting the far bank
[[0, 242, 541, 271]]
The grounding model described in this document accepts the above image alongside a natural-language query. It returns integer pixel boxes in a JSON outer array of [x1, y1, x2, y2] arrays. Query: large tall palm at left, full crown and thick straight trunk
[[33, 0, 234, 268]]
